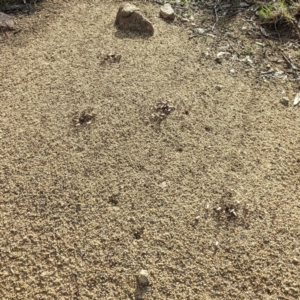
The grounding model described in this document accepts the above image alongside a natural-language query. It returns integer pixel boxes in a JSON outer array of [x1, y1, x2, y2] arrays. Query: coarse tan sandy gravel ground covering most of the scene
[[0, 0, 300, 300]]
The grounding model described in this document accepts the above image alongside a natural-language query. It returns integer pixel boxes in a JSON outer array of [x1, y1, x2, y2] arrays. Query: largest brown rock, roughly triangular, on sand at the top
[[115, 3, 154, 35]]
